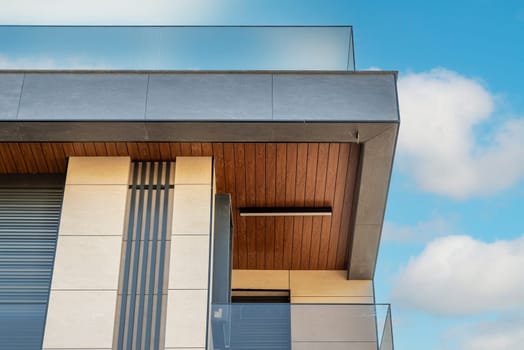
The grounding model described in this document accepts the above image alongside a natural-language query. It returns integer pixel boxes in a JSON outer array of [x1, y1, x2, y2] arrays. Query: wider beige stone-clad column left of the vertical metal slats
[[43, 157, 131, 349]]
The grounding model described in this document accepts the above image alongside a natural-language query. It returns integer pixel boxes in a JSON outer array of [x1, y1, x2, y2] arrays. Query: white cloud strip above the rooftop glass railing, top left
[[0, 0, 223, 24]]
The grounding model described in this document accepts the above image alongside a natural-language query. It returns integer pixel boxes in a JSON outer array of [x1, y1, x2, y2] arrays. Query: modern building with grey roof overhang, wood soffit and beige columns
[[0, 27, 399, 350]]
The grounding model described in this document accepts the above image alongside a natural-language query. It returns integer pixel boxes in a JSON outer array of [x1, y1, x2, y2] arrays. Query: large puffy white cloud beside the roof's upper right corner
[[398, 69, 524, 199]]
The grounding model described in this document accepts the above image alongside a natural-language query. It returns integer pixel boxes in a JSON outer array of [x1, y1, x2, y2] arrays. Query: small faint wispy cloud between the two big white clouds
[[382, 215, 452, 243]]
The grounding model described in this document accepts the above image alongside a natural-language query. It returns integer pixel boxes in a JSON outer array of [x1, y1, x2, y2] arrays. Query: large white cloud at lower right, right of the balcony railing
[[393, 236, 524, 315]]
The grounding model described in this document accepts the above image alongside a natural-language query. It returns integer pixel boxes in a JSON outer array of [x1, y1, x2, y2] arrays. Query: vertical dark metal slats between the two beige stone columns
[[115, 162, 175, 350]]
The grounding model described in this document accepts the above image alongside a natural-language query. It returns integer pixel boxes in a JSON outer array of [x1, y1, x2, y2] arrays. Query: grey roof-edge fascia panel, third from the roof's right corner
[[18, 73, 148, 120]]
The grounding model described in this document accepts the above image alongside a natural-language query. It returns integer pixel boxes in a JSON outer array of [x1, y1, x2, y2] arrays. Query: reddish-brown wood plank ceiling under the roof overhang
[[0, 142, 360, 270]]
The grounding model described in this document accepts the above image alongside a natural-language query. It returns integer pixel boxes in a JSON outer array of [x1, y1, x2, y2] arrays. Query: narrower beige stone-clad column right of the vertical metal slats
[[165, 157, 213, 350]]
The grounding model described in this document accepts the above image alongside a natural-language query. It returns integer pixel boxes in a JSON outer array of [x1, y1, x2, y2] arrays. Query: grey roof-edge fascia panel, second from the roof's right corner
[[147, 74, 271, 120]]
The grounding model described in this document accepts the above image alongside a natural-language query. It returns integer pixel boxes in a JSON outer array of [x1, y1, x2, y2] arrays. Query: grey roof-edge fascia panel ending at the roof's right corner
[[273, 73, 398, 121]]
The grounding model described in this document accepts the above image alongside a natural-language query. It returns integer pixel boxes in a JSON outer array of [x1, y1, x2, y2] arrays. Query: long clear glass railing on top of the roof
[[0, 26, 355, 71]]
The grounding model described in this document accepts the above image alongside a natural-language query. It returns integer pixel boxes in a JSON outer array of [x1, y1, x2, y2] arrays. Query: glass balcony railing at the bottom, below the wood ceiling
[[211, 304, 394, 350]]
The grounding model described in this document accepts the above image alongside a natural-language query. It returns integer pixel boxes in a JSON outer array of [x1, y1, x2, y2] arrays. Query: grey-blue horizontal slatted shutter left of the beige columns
[[0, 180, 63, 350]]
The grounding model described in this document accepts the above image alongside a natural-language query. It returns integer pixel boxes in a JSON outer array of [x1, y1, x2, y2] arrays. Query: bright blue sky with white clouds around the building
[[0, 0, 524, 350]]
